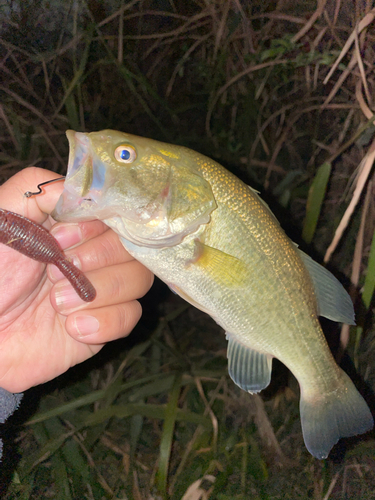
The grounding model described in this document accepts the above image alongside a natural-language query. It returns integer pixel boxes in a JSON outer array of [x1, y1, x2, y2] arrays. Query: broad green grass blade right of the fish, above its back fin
[[302, 163, 331, 243]]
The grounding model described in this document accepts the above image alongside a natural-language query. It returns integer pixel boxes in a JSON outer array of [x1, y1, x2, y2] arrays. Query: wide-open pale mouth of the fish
[[51, 130, 105, 222]]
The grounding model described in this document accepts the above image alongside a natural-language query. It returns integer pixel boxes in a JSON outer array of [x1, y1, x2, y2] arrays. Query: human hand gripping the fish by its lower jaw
[[0, 167, 153, 392]]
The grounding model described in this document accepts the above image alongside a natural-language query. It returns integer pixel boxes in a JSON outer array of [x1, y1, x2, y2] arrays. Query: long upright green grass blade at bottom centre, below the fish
[[156, 375, 182, 498]]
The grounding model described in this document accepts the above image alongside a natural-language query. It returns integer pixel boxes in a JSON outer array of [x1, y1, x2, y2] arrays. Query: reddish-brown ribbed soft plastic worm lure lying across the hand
[[0, 209, 96, 302]]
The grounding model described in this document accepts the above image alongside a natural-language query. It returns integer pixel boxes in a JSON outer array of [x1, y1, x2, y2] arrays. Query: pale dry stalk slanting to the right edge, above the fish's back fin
[[324, 135, 375, 264]]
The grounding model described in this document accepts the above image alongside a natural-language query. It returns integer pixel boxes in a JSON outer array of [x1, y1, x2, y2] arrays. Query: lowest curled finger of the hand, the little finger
[[65, 300, 142, 344]]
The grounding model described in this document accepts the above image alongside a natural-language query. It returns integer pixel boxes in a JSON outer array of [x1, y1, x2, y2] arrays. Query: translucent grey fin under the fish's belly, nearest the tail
[[226, 333, 272, 393]]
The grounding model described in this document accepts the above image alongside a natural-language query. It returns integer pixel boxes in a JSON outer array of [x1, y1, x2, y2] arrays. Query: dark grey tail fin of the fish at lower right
[[300, 372, 374, 459]]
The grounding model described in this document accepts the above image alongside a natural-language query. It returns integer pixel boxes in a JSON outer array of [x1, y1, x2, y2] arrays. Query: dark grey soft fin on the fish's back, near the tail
[[298, 250, 355, 325]]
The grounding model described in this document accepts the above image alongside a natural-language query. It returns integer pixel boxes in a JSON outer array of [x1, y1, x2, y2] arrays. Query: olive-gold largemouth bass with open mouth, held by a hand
[[52, 130, 373, 459]]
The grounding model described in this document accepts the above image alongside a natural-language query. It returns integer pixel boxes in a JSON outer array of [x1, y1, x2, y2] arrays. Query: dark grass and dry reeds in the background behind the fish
[[0, 0, 375, 500]]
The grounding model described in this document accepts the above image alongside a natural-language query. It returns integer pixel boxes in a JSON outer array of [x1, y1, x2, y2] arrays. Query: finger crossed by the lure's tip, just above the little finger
[[51, 260, 153, 315]]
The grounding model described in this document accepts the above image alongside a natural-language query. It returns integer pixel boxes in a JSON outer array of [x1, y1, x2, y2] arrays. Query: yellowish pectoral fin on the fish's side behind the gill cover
[[188, 240, 250, 287]]
